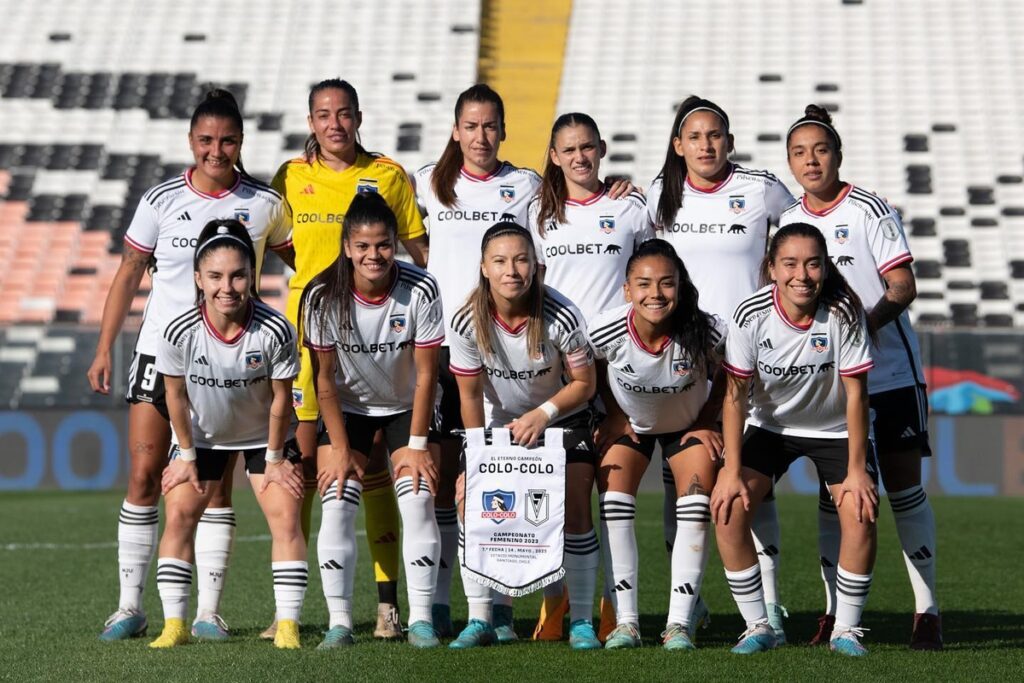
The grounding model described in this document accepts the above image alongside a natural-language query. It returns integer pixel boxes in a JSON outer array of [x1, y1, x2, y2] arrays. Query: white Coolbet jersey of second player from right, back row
[[647, 166, 794, 319]]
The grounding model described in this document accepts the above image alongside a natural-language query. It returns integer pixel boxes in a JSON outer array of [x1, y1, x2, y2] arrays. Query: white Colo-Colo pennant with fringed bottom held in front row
[[460, 429, 565, 597]]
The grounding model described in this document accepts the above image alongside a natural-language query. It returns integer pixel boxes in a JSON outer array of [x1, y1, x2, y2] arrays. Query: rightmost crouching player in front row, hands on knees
[[711, 223, 879, 655]]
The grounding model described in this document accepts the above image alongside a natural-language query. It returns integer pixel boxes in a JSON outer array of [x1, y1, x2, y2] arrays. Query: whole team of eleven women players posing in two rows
[[89, 79, 942, 655]]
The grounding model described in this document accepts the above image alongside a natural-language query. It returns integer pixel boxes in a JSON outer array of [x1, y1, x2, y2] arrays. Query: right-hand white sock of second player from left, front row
[[394, 476, 441, 624]]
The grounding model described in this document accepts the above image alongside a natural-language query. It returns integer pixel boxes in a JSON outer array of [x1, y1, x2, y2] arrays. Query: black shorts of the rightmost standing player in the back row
[[869, 384, 932, 458]]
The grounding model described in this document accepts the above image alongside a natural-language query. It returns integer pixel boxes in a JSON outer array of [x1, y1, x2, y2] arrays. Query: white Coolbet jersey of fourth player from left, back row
[[528, 189, 654, 324]]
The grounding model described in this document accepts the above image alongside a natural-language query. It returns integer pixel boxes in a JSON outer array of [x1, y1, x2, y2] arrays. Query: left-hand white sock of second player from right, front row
[[598, 490, 640, 624]]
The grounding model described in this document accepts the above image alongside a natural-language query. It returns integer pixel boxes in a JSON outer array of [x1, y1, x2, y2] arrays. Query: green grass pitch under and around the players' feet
[[0, 487, 1024, 681]]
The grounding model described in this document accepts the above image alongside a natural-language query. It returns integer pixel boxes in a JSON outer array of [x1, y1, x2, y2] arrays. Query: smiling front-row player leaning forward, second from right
[[590, 240, 725, 650]]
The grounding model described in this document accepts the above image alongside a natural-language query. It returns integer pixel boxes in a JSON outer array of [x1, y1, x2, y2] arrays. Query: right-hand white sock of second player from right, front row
[[668, 495, 711, 626]]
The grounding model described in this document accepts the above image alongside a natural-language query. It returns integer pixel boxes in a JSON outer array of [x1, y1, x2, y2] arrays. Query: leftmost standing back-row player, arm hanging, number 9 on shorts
[[88, 90, 293, 640]]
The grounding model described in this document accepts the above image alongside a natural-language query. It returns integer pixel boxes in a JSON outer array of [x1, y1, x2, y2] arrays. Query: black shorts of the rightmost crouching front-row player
[[740, 427, 879, 485]]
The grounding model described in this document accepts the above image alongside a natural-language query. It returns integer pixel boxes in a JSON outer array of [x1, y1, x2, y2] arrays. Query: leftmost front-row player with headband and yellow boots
[[150, 219, 308, 649]]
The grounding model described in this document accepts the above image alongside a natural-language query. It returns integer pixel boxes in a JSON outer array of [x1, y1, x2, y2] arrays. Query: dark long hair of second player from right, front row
[[626, 239, 715, 379]]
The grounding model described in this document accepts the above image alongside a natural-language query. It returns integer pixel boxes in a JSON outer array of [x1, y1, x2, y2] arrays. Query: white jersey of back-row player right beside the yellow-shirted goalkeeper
[[413, 162, 541, 339]]
